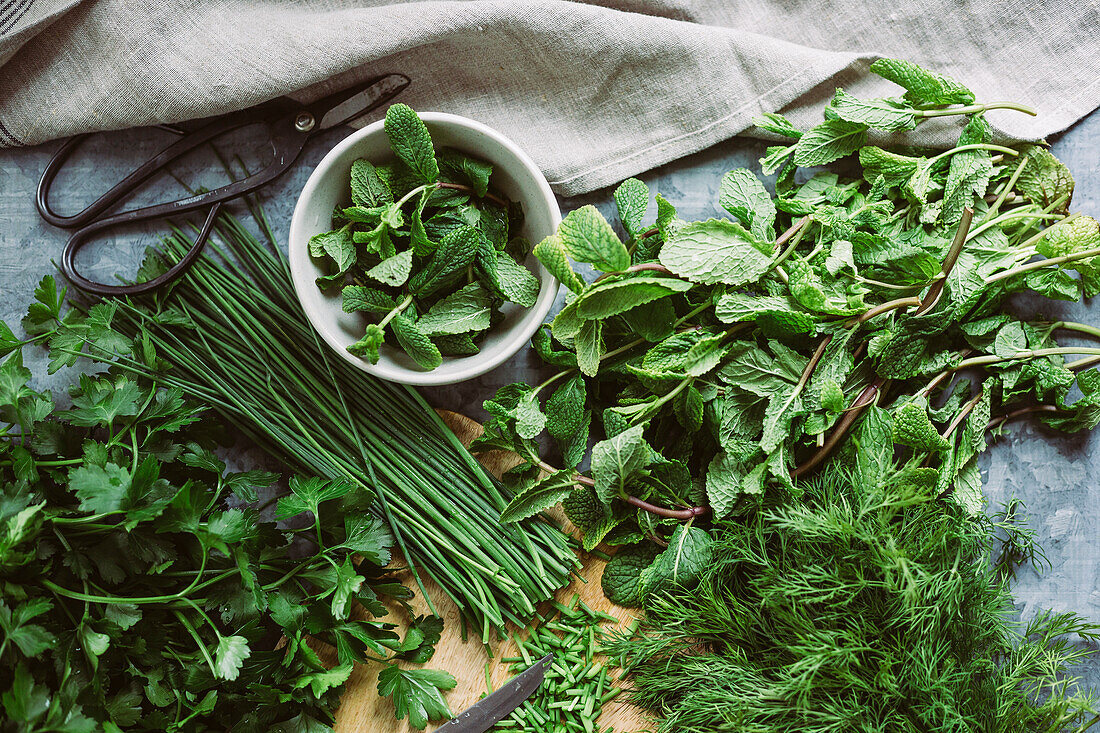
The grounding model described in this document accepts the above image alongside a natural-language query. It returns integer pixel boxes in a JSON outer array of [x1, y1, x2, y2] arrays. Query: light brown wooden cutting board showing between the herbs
[[322, 411, 656, 733]]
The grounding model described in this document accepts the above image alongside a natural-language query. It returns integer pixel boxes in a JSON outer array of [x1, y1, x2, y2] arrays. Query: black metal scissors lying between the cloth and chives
[[35, 74, 409, 295]]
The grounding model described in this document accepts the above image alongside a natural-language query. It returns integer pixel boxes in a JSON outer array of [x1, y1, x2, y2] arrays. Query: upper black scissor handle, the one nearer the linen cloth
[[35, 100, 297, 229]]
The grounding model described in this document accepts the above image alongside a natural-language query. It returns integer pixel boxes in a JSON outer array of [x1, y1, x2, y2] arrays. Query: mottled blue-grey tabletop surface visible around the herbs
[[0, 112, 1100, 690]]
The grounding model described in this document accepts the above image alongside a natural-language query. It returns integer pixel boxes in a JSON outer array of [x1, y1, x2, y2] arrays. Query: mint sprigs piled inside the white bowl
[[309, 105, 539, 370]]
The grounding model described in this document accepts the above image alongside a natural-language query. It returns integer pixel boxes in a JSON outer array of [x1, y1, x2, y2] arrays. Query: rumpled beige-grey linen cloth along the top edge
[[0, 0, 1100, 195]]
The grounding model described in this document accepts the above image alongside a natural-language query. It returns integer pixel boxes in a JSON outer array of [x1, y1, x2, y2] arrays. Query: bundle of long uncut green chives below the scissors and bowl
[[82, 209, 578, 641]]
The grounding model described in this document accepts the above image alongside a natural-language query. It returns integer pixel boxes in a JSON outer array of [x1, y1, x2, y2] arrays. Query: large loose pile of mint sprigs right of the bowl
[[474, 59, 1100, 603]]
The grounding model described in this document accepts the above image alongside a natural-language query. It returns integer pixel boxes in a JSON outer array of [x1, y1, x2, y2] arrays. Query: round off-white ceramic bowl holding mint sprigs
[[289, 112, 561, 385]]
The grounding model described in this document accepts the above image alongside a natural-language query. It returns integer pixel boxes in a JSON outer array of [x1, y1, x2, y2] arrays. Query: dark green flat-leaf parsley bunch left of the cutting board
[[0, 327, 454, 733]]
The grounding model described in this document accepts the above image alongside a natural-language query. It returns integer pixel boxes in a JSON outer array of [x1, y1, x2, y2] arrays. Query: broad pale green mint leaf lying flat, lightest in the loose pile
[[660, 219, 773, 285]]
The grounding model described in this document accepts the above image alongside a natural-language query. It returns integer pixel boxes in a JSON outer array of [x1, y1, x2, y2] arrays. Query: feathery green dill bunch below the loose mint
[[607, 464, 1100, 733]]
